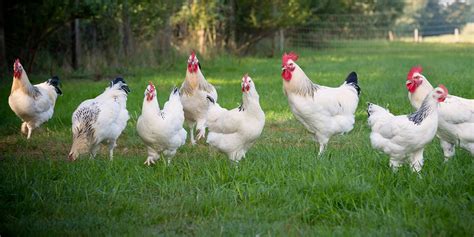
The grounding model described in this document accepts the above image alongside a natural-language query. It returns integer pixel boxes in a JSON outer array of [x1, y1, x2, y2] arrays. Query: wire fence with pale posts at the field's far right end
[[284, 14, 474, 48]]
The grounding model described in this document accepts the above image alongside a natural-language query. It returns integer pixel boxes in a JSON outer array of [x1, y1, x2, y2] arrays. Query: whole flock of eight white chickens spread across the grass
[[8, 53, 474, 172]]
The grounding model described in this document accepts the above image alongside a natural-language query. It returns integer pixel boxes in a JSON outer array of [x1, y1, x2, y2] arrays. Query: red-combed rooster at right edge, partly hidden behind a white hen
[[406, 67, 474, 160]]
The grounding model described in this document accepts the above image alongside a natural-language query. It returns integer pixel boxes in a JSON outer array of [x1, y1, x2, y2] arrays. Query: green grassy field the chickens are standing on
[[0, 43, 474, 236]]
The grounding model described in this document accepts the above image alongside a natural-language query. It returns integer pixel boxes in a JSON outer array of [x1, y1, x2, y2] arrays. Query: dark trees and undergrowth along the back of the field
[[0, 0, 468, 76]]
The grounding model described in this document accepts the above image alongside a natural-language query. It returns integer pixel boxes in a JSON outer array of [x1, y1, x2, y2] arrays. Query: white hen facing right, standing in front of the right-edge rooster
[[367, 85, 448, 172]]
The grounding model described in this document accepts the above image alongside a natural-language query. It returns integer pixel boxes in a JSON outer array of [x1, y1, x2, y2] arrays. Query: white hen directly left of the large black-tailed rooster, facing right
[[206, 75, 265, 162]]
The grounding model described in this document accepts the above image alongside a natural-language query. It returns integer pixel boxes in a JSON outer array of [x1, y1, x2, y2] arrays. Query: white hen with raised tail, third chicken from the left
[[137, 82, 187, 165]]
